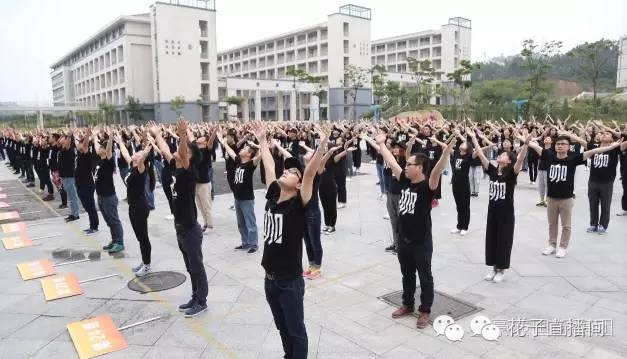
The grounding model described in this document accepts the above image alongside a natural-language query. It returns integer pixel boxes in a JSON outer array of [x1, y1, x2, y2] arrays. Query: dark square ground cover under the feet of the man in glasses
[[379, 288, 483, 322]]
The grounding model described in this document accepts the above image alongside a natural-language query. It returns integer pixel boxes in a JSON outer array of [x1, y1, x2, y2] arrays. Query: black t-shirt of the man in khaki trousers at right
[[541, 149, 585, 198]]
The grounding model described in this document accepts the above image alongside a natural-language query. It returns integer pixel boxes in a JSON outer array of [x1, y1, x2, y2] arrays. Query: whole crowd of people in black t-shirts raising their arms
[[0, 116, 627, 358]]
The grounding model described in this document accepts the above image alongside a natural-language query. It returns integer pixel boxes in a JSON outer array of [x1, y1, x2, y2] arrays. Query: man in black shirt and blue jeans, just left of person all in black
[[59, 132, 79, 222]]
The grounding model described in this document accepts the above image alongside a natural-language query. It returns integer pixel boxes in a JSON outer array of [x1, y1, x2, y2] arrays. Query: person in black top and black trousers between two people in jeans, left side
[[75, 133, 100, 235]]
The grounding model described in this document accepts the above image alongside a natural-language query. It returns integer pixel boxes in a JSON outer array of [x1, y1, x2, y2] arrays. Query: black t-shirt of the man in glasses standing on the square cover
[[398, 171, 434, 243]]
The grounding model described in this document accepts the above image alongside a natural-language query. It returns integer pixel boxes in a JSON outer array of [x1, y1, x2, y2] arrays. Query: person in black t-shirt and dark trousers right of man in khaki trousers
[[587, 131, 627, 235]]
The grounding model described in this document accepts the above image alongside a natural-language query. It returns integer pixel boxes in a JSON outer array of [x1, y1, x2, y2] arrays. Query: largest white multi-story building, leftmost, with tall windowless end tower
[[51, 0, 218, 122]]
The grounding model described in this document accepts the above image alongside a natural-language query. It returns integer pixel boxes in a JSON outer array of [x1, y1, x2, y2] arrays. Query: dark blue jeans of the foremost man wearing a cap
[[265, 274, 307, 359]]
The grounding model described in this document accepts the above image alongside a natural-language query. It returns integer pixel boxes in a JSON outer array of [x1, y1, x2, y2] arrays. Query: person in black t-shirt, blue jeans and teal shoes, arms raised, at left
[[93, 134, 124, 254]]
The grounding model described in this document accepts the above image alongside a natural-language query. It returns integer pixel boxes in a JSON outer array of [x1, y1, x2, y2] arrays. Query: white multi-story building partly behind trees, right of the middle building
[[370, 17, 472, 104]]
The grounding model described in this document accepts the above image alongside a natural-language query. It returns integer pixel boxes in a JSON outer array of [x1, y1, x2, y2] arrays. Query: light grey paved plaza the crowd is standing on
[[0, 164, 627, 359]]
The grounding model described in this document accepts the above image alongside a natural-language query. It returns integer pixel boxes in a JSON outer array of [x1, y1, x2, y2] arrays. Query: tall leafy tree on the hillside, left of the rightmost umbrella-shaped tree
[[520, 39, 562, 115]]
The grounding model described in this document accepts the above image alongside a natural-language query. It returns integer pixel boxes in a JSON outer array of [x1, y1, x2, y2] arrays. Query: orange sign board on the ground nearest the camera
[[67, 315, 128, 359]]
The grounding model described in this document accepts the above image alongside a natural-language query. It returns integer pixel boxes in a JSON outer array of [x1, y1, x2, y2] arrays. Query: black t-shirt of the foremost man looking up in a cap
[[261, 181, 306, 276]]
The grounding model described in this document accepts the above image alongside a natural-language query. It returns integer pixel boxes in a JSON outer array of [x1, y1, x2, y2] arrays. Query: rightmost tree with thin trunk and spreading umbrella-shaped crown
[[566, 39, 618, 117]]
